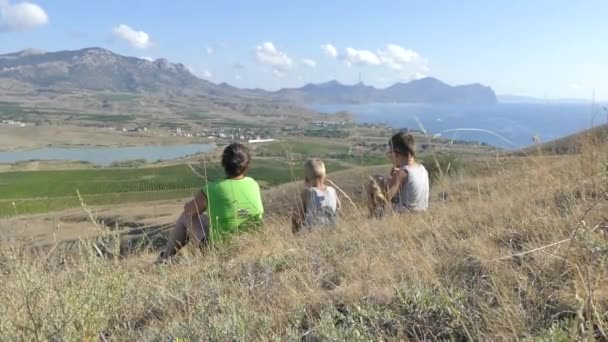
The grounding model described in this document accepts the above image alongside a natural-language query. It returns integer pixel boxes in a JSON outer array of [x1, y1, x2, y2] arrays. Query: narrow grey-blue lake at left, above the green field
[[0, 144, 215, 166]]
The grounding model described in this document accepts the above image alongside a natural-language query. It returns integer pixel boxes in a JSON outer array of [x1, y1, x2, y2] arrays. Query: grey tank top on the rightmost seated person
[[397, 164, 429, 211]]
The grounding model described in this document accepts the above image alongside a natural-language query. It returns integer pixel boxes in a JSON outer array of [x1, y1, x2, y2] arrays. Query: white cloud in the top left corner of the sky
[[0, 0, 49, 31]]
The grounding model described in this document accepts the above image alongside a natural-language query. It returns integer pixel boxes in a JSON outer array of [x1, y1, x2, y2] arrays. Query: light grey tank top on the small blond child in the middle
[[304, 186, 338, 228]]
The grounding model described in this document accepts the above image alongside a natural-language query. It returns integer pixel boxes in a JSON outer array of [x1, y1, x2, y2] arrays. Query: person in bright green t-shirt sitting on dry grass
[[158, 143, 264, 262]]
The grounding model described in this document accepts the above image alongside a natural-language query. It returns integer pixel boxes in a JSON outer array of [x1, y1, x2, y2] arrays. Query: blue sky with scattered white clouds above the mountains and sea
[[0, 0, 608, 101]]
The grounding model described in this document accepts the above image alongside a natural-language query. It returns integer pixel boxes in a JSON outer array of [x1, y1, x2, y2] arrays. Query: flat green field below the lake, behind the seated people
[[0, 159, 364, 217]]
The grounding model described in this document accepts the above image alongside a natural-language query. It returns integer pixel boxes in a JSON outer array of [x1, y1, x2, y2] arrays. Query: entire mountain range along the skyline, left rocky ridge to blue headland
[[0, 48, 497, 104]]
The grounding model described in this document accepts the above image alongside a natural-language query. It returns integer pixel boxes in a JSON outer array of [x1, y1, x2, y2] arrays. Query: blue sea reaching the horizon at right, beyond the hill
[[312, 103, 607, 148]]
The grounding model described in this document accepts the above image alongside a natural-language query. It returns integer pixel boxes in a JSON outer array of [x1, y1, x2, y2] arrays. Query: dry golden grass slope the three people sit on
[[0, 141, 608, 341]]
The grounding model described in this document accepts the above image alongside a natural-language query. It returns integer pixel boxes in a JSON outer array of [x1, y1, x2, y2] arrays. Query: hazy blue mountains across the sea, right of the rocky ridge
[[273, 77, 497, 104]]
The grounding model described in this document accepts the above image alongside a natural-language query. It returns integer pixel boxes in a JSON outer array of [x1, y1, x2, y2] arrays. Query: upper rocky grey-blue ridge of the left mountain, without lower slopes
[[0, 48, 222, 93]]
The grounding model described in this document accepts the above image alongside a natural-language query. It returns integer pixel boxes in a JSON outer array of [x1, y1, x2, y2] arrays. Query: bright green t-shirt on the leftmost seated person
[[202, 177, 264, 242]]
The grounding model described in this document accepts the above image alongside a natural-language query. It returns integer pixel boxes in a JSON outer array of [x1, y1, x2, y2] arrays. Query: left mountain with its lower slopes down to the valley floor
[[0, 48, 324, 126]]
